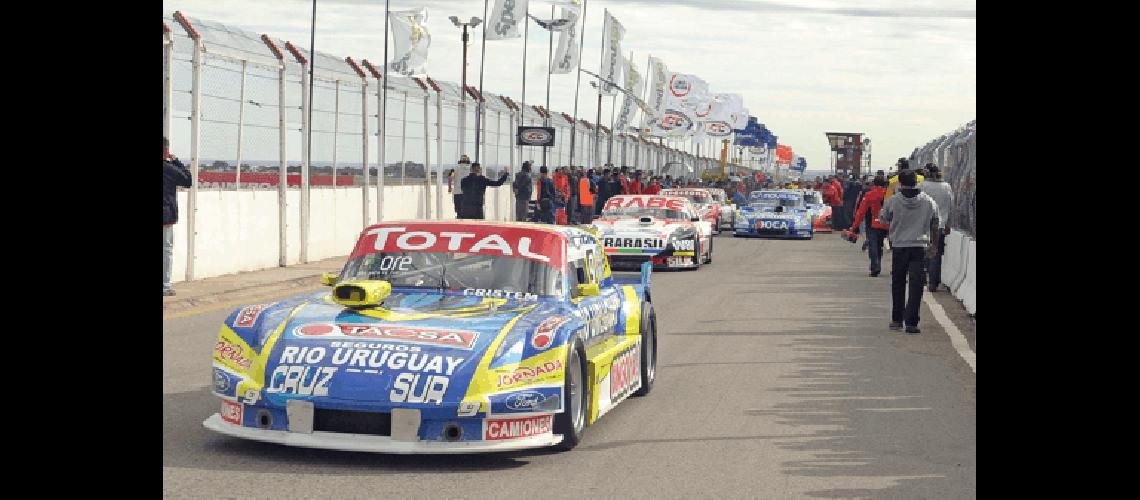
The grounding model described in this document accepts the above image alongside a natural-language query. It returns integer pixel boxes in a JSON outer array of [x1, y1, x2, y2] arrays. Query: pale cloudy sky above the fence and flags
[[162, 0, 977, 170]]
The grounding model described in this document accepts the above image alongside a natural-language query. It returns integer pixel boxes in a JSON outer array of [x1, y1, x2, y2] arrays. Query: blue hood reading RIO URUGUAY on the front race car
[[228, 292, 574, 415]]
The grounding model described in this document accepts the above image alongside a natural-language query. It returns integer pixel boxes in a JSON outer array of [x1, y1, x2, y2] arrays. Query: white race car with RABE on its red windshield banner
[[593, 195, 713, 269]]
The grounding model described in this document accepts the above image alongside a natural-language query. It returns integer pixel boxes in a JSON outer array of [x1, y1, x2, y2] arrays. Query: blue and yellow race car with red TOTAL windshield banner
[[203, 221, 657, 453]]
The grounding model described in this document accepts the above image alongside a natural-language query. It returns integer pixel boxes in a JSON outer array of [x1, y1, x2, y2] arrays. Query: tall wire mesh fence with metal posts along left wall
[[163, 13, 715, 279]]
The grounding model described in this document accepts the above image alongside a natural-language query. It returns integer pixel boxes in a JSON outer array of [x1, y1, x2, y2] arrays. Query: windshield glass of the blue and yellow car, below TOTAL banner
[[340, 252, 562, 296]]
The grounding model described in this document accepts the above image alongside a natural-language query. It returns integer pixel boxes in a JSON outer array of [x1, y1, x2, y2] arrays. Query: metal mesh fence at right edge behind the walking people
[[910, 120, 978, 239]]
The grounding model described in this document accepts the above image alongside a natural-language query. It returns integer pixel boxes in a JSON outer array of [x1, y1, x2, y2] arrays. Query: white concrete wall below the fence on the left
[[171, 185, 512, 281]]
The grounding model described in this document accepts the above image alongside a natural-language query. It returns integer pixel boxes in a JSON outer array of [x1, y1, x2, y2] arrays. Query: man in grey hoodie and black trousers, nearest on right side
[[879, 169, 939, 335]]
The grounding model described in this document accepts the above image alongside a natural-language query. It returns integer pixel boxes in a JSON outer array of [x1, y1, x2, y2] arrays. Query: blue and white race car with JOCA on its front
[[733, 189, 814, 239]]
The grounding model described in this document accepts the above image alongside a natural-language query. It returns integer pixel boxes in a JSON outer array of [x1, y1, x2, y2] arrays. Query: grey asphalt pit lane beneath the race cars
[[162, 233, 977, 498]]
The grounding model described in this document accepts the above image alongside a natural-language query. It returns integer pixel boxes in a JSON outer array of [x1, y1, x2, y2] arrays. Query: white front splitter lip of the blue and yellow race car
[[202, 413, 562, 454]]
